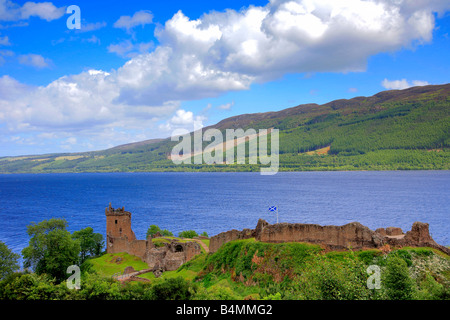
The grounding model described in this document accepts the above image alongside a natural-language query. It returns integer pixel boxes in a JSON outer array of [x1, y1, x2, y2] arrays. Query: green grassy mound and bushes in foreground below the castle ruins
[[0, 239, 450, 300]]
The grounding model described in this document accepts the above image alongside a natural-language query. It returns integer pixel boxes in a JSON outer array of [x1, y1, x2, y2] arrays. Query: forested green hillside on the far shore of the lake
[[0, 84, 450, 173]]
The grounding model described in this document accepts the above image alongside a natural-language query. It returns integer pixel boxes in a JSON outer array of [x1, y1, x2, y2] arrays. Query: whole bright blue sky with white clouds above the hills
[[0, 0, 450, 156]]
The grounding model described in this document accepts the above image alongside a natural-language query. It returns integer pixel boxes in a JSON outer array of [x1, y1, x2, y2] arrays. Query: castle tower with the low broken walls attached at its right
[[105, 204, 201, 275]]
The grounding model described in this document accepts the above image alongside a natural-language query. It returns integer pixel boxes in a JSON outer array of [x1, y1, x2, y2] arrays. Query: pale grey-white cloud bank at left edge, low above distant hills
[[0, 70, 179, 133]]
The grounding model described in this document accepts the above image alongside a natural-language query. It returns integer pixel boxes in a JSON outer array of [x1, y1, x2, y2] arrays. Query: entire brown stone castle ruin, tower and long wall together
[[105, 204, 450, 276]]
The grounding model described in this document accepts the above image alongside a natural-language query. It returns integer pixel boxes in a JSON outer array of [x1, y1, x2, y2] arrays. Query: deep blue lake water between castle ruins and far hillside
[[0, 171, 450, 253]]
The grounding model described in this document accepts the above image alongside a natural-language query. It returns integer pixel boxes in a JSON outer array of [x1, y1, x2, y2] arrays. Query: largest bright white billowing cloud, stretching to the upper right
[[112, 0, 450, 104]]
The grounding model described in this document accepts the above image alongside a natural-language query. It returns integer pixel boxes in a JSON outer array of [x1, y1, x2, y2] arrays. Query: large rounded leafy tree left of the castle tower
[[22, 218, 80, 281]]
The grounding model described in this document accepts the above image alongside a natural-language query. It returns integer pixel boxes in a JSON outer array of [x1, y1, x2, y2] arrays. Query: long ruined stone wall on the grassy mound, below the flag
[[209, 219, 450, 254]]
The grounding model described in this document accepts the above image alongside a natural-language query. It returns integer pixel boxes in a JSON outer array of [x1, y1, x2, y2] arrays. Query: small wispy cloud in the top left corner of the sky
[[0, 0, 65, 21]]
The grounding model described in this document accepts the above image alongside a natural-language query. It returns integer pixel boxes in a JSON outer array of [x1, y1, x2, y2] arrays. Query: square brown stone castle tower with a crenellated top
[[105, 203, 136, 244]]
